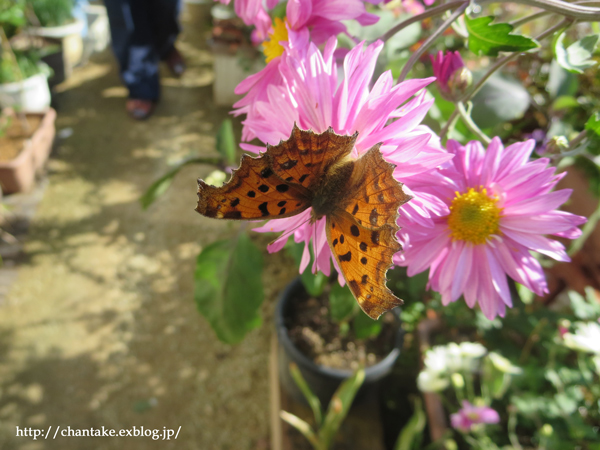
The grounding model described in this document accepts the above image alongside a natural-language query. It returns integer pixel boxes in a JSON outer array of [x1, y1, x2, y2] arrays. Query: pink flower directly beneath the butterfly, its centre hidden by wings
[[234, 38, 451, 282]]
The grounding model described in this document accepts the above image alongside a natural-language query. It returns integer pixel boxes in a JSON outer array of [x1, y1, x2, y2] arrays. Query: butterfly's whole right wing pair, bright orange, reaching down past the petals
[[327, 146, 410, 319]]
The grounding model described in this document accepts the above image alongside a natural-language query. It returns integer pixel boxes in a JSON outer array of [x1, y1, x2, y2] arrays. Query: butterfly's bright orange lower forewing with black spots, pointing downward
[[327, 211, 403, 319]]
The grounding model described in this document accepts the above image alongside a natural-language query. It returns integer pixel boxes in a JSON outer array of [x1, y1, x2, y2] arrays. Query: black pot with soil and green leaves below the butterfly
[[275, 274, 402, 405]]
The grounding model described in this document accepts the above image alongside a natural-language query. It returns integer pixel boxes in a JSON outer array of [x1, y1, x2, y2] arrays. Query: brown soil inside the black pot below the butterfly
[[285, 295, 398, 370]]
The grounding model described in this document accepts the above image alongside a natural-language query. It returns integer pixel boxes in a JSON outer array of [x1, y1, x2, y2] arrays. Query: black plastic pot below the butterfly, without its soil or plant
[[275, 278, 403, 408]]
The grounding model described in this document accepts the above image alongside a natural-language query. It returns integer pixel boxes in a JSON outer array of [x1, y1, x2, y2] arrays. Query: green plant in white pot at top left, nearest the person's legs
[[26, 0, 85, 78]]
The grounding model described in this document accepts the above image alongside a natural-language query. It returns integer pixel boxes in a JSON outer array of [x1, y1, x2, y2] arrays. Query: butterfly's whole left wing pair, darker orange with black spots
[[196, 124, 358, 220]]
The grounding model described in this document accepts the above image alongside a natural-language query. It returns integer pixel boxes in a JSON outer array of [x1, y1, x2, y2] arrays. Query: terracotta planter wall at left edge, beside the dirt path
[[0, 108, 56, 194]]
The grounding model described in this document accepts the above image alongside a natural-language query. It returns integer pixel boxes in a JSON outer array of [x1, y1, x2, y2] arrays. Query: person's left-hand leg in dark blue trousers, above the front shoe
[[104, 0, 160, 102]]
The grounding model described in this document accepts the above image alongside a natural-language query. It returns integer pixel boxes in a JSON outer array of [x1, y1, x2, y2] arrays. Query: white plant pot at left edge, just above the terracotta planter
[[0, 73, 50, 113]]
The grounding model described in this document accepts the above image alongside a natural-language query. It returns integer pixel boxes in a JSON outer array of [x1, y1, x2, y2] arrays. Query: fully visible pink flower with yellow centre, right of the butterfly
[[394, 137, 586, 319]]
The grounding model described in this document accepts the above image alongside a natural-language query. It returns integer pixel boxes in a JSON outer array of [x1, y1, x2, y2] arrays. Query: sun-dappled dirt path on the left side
[[0, 7, 293, 450]]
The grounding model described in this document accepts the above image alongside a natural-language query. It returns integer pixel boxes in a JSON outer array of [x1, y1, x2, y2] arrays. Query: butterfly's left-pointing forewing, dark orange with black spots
[[196, 155, 310, 220]]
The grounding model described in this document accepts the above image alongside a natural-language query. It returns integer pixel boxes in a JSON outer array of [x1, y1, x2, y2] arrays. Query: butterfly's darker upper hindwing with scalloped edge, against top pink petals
[[267, 125, 358, 189]]
